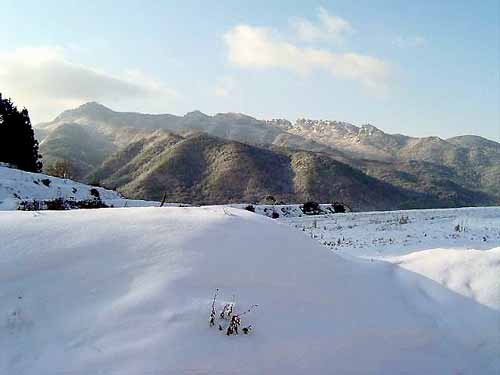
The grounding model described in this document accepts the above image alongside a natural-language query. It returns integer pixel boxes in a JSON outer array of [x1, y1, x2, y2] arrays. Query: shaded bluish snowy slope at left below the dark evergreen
[[0, 164, 159, 211]]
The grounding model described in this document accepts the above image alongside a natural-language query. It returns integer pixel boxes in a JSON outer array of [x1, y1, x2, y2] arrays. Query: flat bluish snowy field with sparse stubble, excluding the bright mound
[[280, 207, 500, 259]]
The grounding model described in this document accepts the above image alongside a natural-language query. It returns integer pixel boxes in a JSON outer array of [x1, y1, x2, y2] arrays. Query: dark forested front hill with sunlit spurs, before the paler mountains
[[91, 134, 450, 210]]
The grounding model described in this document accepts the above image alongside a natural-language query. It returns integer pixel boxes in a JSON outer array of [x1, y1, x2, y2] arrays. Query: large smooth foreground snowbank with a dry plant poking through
[[0, 207, 500, 375]]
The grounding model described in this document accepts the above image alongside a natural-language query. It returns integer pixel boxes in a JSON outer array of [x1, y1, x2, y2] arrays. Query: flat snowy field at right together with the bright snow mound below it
[[281, 207, 500, 314]]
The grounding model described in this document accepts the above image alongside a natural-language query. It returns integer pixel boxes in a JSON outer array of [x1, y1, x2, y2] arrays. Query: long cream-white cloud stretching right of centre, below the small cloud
[[224, 25, 389, 88]]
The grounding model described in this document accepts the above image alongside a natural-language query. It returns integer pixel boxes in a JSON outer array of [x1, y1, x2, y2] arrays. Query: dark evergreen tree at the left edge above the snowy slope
[[0, 93, 42, 172]]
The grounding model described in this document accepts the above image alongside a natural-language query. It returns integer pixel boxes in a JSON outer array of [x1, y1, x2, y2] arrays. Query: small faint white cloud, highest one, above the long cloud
[[291, 7, 354, 42]]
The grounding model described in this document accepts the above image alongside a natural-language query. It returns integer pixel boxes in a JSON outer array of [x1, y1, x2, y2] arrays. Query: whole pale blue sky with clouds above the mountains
[[0, 0, 500, 141]]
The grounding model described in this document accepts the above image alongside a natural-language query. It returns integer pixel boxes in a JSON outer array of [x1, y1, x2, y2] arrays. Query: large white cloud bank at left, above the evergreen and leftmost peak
[[0, 47, 176, 122]]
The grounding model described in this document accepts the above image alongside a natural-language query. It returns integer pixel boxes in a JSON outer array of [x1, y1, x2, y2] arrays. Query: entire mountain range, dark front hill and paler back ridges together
[[36, 102, 500, 209]]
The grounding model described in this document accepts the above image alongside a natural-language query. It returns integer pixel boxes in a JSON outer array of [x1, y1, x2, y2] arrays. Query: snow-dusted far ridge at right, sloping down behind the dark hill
[[270, 119, 500, 197]]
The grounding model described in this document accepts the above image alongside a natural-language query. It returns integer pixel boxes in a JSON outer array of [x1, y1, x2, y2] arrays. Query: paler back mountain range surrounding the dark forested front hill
[[36, 102, 500, 208]]
